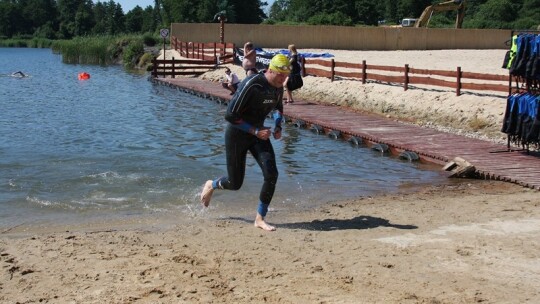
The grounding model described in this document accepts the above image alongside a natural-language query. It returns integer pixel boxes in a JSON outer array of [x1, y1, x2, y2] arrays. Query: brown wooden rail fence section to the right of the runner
[[302, 58, 511, 96]]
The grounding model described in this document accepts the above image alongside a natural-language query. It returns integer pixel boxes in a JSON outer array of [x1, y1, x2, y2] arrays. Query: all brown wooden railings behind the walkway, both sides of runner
[[157, 36, 512, 96]]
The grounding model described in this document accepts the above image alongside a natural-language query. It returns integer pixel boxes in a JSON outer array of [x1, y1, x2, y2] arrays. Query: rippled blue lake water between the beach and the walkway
[[0, 48, 450, 231]]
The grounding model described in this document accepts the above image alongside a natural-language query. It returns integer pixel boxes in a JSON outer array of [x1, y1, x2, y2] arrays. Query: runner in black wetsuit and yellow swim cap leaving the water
[[201, 54, 290, 231]]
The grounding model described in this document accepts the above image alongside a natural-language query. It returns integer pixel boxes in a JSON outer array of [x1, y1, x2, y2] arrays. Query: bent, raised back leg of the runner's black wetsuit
[[216, 125, 256, 190]]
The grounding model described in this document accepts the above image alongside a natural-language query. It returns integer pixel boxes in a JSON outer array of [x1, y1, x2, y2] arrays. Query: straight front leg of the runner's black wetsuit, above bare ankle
[[249, 139, 278, 204]]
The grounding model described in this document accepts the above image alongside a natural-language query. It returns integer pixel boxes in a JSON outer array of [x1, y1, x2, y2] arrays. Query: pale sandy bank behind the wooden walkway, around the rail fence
[[194, 49, 508, 142]]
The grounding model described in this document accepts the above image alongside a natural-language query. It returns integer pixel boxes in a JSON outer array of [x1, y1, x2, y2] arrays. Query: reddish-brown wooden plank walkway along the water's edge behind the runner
[[152, 78, 540, 190]]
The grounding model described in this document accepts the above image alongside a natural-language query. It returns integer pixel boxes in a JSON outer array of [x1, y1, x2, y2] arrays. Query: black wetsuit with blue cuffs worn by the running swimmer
[[215, 73, 283, 204]]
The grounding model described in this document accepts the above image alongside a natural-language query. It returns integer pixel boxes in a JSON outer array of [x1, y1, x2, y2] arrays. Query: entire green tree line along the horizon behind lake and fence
[[0, 0, 540, 39]]
